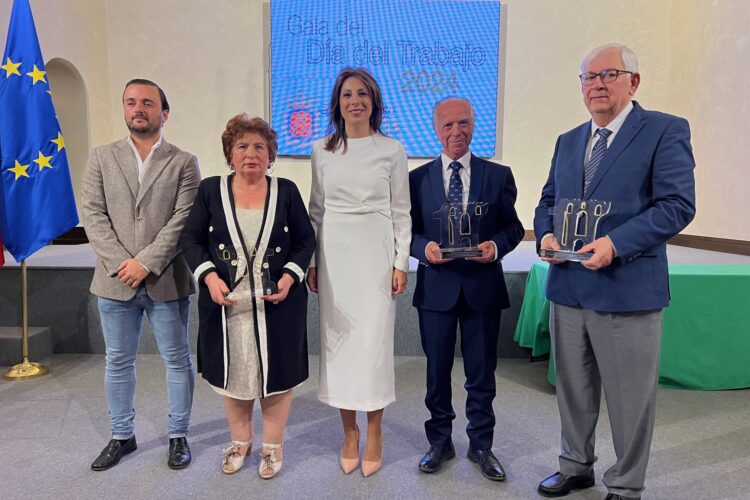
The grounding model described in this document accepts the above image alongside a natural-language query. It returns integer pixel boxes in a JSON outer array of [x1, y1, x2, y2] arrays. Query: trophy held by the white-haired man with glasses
[[539, 199, 612, 262]]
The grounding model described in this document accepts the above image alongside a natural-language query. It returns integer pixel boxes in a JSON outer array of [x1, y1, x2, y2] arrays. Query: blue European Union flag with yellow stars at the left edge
[[0, 0, 78, 262]]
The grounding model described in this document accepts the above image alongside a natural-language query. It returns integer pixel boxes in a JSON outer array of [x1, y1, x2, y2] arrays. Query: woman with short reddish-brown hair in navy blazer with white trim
[[180, 114, 315, 479]]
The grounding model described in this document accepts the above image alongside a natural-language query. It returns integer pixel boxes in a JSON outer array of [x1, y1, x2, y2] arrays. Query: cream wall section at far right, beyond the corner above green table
[[667, 0, 750, 241]]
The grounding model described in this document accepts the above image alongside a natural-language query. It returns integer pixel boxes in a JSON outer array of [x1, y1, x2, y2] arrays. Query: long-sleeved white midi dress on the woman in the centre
[[310, 134, 418, 411]]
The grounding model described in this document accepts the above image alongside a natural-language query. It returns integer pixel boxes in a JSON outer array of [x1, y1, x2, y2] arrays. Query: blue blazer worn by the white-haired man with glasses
[[534, 101, 695, 312]]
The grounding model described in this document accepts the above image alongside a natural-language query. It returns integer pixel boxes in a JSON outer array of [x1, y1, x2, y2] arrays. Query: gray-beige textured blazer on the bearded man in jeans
[[81, 139, 200, 302]]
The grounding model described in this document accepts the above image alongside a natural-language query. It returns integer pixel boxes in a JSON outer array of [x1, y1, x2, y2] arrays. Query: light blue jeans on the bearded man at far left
[[99, 285, 195, 439]]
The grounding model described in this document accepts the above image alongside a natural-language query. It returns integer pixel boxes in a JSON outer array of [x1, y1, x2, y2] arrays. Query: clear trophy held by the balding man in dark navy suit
[[432, 201, 487, 259]]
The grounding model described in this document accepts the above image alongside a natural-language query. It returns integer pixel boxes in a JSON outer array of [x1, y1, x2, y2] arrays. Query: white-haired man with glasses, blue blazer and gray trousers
[[534, 44, 695, 499]]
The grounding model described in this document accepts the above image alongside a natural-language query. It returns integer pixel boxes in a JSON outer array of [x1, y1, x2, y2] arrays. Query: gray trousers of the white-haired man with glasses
[[550, 303, 661, 497]]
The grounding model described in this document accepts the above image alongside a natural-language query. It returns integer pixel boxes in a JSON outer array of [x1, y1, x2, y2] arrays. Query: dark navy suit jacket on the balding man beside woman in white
[[409, 155, 524, 311]]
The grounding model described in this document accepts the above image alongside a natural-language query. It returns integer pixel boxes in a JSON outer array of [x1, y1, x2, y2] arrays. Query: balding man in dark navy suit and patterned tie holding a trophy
[[409, 97, 524, 481]]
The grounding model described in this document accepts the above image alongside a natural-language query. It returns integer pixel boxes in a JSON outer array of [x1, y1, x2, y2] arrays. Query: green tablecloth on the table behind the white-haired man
[[514, 262, 750, 390]]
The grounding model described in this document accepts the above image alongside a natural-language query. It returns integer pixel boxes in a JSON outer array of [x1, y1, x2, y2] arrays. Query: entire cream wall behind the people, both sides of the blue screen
[[0, 0, 750, 240]]
